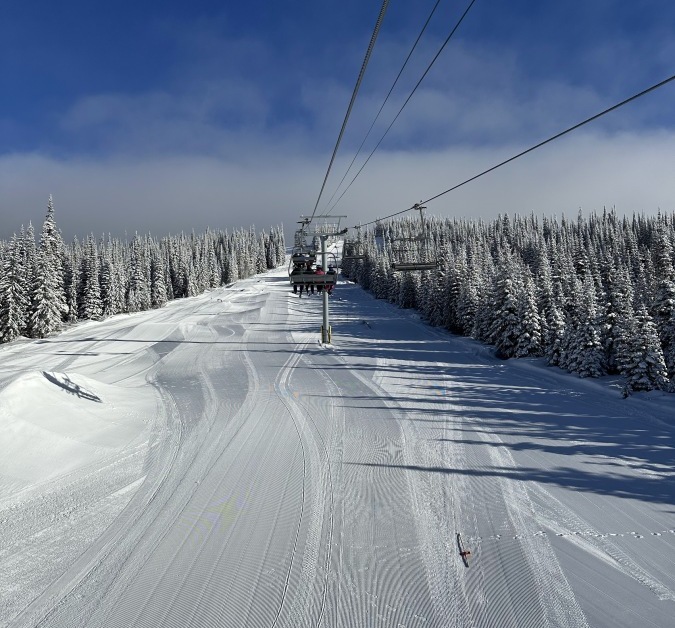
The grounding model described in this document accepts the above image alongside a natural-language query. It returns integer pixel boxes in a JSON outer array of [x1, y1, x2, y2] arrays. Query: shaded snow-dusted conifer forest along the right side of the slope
[[343, 211, 675, 395]]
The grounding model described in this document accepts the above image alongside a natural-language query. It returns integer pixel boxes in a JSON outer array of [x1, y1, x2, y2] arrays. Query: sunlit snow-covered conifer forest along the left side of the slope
[[0, 196, 286, 342]]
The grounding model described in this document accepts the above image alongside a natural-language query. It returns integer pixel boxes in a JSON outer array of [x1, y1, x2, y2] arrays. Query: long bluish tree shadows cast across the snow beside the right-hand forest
[[320, 286, 675, 504]]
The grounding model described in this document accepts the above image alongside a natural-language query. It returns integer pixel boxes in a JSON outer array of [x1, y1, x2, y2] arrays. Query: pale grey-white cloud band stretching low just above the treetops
[[0, 132, 675, 238]]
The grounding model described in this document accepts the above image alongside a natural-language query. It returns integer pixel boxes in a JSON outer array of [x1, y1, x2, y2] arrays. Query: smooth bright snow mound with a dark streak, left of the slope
[[0, 371, 155, 496]]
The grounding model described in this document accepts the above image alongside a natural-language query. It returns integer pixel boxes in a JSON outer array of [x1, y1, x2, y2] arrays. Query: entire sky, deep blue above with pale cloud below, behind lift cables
[[0, 0, 675, 238]]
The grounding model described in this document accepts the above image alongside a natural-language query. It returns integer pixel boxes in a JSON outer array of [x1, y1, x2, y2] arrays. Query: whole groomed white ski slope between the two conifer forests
[[0, 270, 675, 628]]
